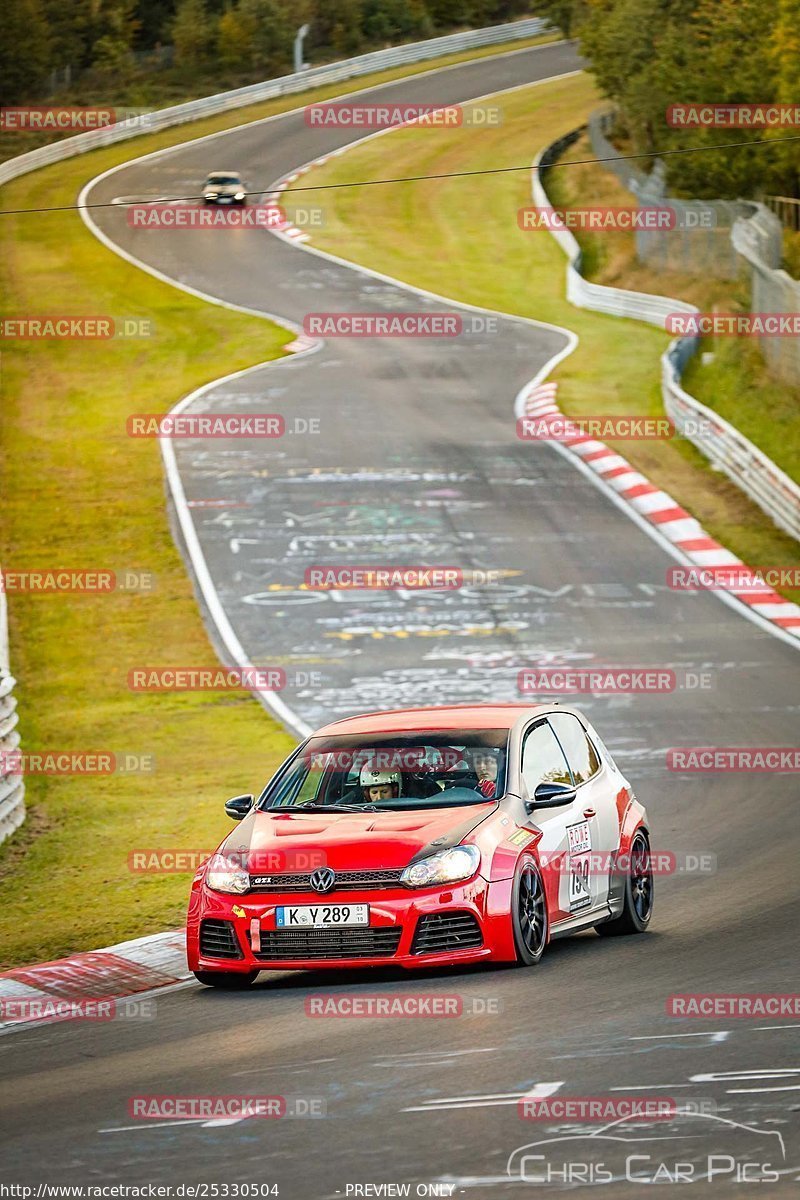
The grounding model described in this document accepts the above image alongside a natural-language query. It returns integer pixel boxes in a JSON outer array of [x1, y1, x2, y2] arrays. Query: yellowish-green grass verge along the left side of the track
[[0, 40, 563, 968]]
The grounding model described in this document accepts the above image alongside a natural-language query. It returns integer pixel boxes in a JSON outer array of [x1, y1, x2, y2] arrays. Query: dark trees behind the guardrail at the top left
[[0, 0, 529, 106]]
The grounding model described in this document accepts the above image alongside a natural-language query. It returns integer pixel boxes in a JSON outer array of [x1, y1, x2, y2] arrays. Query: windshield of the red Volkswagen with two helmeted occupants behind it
[[260, 730, 509, 811]]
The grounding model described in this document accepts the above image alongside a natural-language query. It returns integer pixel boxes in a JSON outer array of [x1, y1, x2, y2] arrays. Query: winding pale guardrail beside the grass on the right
[[531, 130, 800, 539]]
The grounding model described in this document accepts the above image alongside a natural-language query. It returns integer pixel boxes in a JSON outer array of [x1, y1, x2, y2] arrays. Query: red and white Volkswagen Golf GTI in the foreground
[[187, 704, 652, 988]]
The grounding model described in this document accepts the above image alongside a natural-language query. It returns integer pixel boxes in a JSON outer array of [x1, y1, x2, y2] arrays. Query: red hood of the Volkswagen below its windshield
[[219, 802, 493, 874]]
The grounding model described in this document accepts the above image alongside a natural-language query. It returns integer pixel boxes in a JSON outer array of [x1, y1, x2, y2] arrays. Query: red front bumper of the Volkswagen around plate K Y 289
[[187, 876, 516, 973]]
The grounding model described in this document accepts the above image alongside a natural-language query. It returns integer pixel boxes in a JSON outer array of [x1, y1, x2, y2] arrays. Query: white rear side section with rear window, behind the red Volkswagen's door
[[549, 713, 619, 908]]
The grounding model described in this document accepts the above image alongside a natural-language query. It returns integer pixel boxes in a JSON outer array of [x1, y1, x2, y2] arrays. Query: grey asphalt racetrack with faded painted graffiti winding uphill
[[0, 43, 800, 1200]]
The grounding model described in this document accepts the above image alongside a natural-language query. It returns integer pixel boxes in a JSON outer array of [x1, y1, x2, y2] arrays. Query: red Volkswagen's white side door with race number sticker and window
[[522, 718, 593, 922]]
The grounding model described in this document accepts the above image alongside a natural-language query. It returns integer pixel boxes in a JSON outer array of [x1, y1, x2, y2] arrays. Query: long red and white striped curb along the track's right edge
[[517, 382, 800, 638]]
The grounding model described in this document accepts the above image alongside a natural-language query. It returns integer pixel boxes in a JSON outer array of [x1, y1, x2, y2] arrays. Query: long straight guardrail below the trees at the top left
[[0, 17, 552, 184]]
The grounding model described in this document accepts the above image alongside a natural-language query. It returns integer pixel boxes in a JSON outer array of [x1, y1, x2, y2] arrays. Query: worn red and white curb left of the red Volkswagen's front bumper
[[0, 930, 192, 1033]]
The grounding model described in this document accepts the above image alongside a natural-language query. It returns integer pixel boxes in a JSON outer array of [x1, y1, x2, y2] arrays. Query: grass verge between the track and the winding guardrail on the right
[[297, 76, 800, 600]]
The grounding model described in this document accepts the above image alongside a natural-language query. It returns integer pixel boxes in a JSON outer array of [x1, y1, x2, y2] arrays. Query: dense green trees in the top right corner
[[536, 0, 800, 199]]
